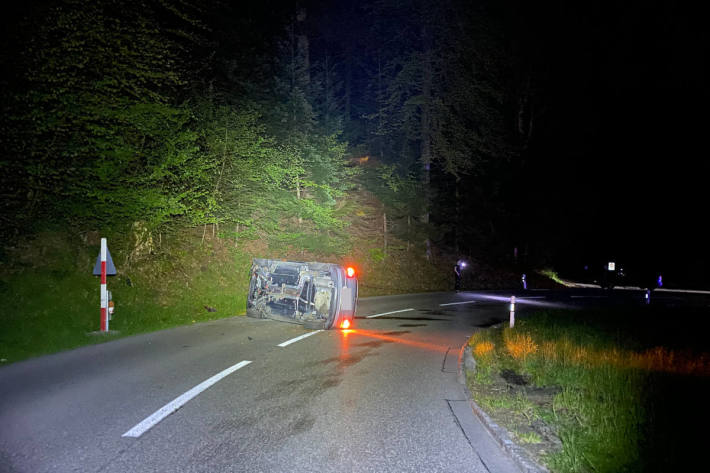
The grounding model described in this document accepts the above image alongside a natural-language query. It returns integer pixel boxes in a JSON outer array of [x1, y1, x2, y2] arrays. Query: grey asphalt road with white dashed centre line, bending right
[[0, 291, 700, 473]]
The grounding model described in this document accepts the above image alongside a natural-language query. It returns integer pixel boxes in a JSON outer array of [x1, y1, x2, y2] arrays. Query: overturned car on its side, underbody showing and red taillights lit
[[247, 258, 357, 329]]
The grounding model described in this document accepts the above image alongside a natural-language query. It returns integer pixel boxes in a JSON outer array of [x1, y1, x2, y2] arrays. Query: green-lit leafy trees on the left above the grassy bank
[[0, 0, 352, 254]]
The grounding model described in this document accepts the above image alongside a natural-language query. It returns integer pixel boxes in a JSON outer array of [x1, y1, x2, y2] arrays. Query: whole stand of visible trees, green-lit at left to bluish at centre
[[0, 0, 514, 258]]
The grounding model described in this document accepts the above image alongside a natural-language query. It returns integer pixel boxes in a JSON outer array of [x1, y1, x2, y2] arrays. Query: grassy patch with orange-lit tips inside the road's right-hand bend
[[469, 307, 710, 472]]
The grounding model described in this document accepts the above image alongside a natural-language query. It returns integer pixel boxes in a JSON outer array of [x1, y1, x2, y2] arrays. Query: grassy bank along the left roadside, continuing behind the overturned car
[[0, 190, 451, 364]]
